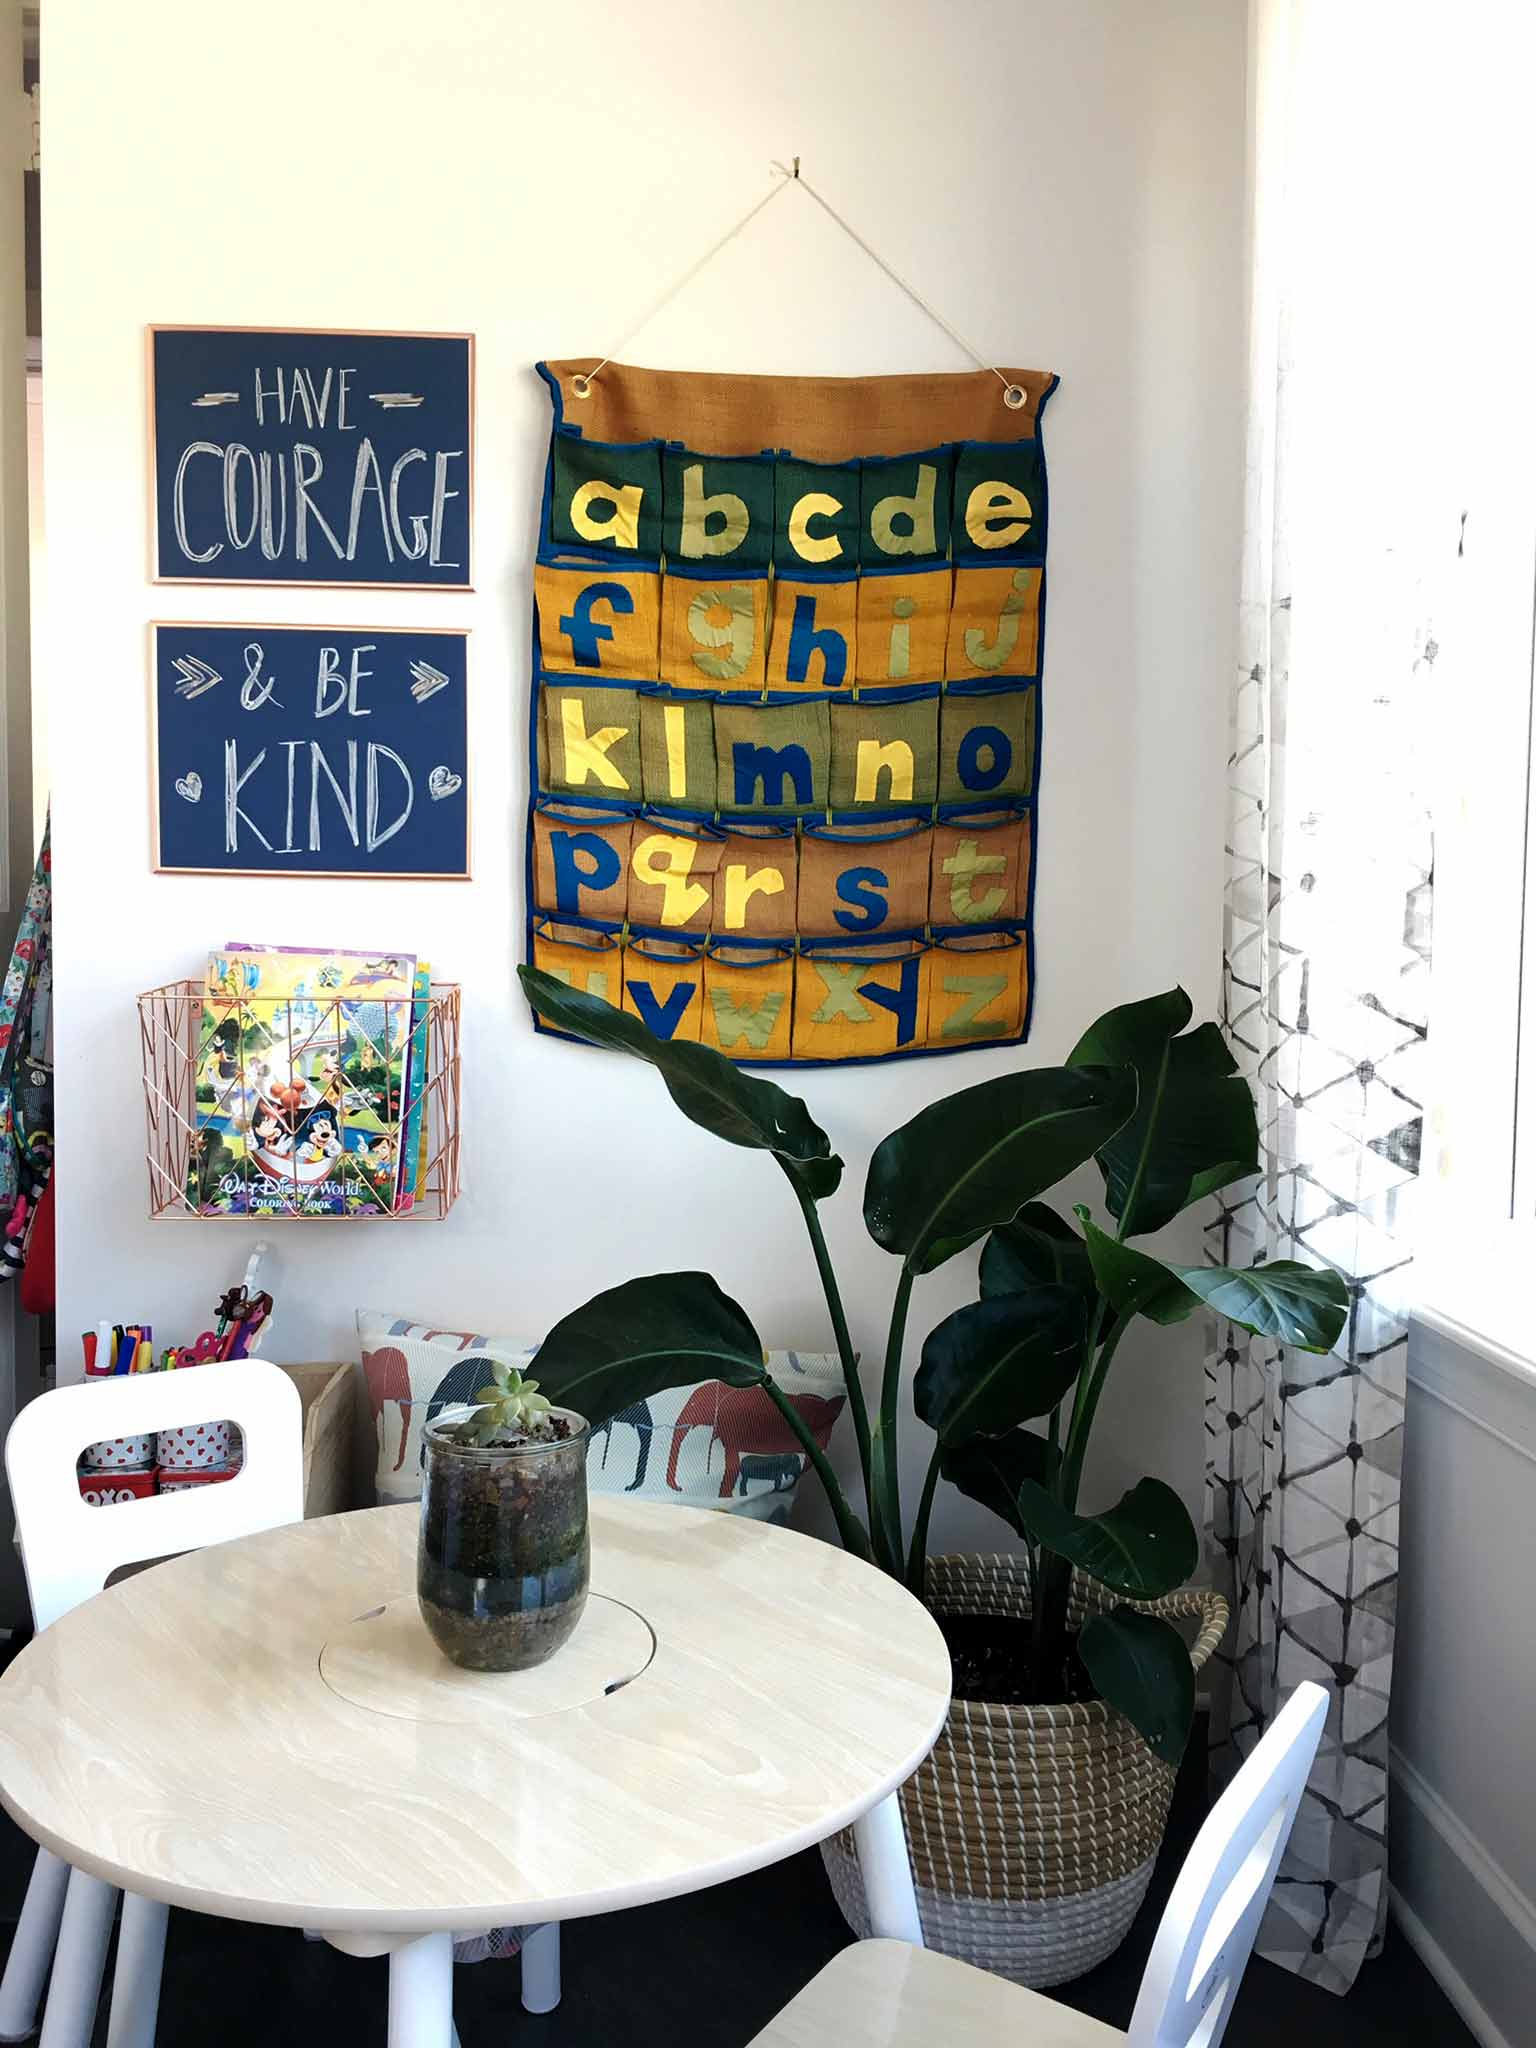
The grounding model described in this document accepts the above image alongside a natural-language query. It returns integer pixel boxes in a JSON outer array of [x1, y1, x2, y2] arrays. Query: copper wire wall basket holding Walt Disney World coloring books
[[139, 981, 459, 1223]]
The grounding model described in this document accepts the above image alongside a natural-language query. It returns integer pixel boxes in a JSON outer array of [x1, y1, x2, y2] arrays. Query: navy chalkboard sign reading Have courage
[[150, 328, 475, 590]]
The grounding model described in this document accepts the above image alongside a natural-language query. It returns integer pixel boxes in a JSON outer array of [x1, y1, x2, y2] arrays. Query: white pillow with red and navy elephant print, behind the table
[[356, 1309, 846, 1522]]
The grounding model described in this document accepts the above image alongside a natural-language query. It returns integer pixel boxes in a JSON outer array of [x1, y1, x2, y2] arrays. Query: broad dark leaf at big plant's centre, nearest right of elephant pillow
[[911, 1284, 1083, 1446]]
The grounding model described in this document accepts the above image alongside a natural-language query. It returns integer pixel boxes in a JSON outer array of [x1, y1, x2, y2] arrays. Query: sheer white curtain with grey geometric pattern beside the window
[[1206, 0, 1440, 1991]]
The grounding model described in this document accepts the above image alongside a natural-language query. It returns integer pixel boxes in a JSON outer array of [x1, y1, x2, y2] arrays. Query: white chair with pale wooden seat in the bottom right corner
[[752, 1683, 1327, 2048]]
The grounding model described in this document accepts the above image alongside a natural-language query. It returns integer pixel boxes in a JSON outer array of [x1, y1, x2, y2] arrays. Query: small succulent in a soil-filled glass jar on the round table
[[416, 1360, 590, 1671]]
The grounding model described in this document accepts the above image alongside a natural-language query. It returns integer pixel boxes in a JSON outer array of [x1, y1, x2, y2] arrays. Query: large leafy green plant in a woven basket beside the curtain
[[520, 967, 1348, 1985]]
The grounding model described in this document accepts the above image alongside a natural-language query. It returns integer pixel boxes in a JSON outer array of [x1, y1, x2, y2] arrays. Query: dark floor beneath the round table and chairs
[[0, 1712, 1473, 2048]]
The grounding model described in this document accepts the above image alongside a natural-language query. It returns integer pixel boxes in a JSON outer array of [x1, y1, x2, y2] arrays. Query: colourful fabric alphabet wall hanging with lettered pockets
[[526, 164, 1057, 1065]]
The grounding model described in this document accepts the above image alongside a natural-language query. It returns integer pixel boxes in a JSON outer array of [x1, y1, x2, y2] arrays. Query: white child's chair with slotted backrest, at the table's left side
[[0, 1358, 303, 2048]]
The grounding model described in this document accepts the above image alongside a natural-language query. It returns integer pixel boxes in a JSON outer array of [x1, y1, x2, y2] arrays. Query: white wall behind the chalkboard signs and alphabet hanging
[[43, 0, 1243, 1538]]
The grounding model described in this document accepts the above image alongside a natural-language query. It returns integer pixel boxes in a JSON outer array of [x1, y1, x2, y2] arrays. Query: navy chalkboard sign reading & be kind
[[152, 625, 469, 879]]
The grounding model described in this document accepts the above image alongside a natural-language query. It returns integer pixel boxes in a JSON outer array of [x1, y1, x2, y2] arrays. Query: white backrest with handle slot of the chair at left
[[6, 1358, 303, 1628]]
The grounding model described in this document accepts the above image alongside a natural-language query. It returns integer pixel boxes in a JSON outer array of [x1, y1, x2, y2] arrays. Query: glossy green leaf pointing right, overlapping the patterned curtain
[[1079, 1210, 1350, 1352]]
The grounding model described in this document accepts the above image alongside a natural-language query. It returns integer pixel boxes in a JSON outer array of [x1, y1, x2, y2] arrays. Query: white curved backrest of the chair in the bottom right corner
[[1126, 1681, 1327, 2048]]
